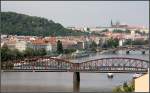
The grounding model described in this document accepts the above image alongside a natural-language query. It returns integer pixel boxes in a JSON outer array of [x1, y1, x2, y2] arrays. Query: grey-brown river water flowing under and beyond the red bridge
[[1, 51, 149, 92]]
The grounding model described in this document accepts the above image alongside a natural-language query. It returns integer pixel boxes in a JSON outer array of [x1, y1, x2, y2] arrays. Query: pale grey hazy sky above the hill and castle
[[1, 1, 149, 27]]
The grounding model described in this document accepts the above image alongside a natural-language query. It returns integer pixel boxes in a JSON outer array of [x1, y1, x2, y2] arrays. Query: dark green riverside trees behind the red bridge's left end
[[1, 45, 46, 69]]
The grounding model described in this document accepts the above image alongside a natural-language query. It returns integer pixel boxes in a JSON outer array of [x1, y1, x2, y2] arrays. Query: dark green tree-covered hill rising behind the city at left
[[1, 12, 87, 36]]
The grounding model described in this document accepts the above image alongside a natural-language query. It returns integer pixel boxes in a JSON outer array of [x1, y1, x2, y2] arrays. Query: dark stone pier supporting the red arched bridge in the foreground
[[73, 72, 80, 93]]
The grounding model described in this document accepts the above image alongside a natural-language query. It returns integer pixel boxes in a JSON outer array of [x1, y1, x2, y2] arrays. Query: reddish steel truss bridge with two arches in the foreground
[[12, 57, 149, 73]]
